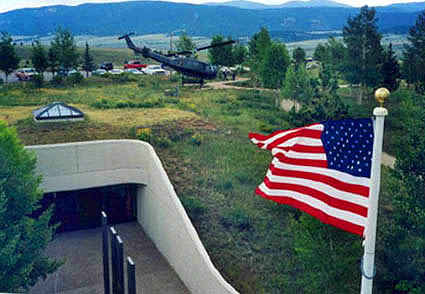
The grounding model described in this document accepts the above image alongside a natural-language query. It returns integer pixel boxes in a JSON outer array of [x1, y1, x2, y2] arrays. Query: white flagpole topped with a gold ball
[[360, 88, 390, 294]]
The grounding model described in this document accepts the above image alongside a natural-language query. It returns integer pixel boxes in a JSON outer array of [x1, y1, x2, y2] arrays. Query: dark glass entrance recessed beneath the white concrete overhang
[[38, 184, 137, 233]]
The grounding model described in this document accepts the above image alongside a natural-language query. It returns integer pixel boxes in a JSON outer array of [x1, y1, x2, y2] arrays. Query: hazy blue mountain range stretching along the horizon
[[0, 0, 425, 41]]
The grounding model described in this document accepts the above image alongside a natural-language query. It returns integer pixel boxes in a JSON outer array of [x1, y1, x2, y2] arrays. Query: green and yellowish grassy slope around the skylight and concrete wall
[[0, 77, 403, 294]]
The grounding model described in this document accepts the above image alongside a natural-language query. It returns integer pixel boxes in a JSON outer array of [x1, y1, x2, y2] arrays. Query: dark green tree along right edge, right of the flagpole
[[377, 105, 425, 294]]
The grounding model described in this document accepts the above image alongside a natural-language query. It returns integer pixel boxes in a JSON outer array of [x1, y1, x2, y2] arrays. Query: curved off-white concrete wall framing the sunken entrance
[[26, 140, 238, 294]]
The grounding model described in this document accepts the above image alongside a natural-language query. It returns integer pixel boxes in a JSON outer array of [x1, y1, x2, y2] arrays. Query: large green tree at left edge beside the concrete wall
[[0, 121, 59, 292]]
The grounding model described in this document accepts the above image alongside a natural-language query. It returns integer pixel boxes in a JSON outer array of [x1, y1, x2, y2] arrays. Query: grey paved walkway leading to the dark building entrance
[[30, 222, 190, 294]]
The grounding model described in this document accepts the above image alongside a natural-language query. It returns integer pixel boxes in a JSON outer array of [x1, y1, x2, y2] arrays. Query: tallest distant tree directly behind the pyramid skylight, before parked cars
[[50, 27, 80, 71]]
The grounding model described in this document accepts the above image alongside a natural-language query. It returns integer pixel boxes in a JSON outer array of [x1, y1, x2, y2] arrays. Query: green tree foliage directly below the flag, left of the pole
[[291, 214, 362, 294]]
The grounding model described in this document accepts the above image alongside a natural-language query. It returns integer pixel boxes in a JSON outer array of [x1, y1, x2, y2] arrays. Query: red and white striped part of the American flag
[[249, 124, 370, 236]]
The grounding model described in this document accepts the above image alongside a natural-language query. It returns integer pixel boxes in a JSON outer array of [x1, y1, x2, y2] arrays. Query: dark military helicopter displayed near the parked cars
[[118, 32, 235, 87]]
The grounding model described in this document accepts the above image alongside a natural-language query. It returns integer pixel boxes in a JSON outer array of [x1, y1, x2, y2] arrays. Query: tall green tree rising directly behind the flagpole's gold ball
[[343, 6, 383, 103]]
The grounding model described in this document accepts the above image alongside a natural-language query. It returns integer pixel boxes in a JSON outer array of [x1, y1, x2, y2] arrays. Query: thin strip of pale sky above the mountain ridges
[[0, 0, 422, 13]]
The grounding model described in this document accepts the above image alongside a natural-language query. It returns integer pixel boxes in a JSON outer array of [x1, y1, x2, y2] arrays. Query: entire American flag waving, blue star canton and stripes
[[249, 119, 373, 236]]
